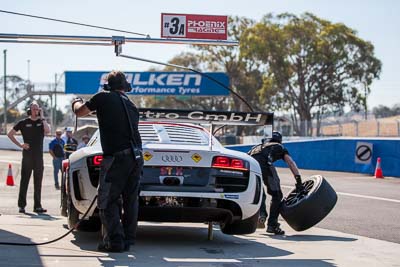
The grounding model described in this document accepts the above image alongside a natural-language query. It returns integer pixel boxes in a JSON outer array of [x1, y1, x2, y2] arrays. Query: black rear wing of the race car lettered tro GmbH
[[139, 108, 274, 126]]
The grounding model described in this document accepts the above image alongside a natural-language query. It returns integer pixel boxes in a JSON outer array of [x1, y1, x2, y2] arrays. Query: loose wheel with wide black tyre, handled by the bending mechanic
[[281, 175, 337, 231]]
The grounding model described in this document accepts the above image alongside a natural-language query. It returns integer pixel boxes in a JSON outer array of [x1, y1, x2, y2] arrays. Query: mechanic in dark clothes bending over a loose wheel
[[248, 131, 302, 235]]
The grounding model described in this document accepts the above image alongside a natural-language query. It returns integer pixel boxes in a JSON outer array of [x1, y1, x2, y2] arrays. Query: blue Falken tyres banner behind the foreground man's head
[[65, 71, 229, 96]]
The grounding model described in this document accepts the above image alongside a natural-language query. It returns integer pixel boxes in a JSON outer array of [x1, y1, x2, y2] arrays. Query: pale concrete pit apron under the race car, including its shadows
[[0, 218, 400, 267]]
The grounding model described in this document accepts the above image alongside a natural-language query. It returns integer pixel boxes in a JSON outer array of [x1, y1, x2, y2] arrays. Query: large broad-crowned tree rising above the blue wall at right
[[240, 13, 381, 135]]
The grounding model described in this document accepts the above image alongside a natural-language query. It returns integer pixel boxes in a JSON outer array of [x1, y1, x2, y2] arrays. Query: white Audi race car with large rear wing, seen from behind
[[61, 109, 273, 234]]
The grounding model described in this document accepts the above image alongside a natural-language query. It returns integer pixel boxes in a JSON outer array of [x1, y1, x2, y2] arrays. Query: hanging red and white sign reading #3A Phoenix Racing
[[161, 13, 228, 40]]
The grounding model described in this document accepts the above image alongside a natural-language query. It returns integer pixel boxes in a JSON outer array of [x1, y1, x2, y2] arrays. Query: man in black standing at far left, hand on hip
[[7, 102, 50, 213]]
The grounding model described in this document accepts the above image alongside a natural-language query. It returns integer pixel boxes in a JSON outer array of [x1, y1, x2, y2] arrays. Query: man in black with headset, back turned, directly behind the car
[[72, 71, 143, 252]]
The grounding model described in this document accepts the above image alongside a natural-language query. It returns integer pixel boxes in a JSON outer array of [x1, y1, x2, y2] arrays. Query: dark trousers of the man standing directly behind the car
[[97, 153, 141, 249]]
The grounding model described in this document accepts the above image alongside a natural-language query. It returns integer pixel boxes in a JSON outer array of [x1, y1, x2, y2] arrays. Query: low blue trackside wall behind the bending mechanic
[[227, 138, 400, 177]]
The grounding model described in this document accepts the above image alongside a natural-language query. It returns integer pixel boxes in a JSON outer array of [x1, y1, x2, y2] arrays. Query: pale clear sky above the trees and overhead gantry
[[0, 0, 400, 108]]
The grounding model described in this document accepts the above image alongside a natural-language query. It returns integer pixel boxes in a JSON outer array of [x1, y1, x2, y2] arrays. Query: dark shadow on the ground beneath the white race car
[[72, 225, 334, 267]]
